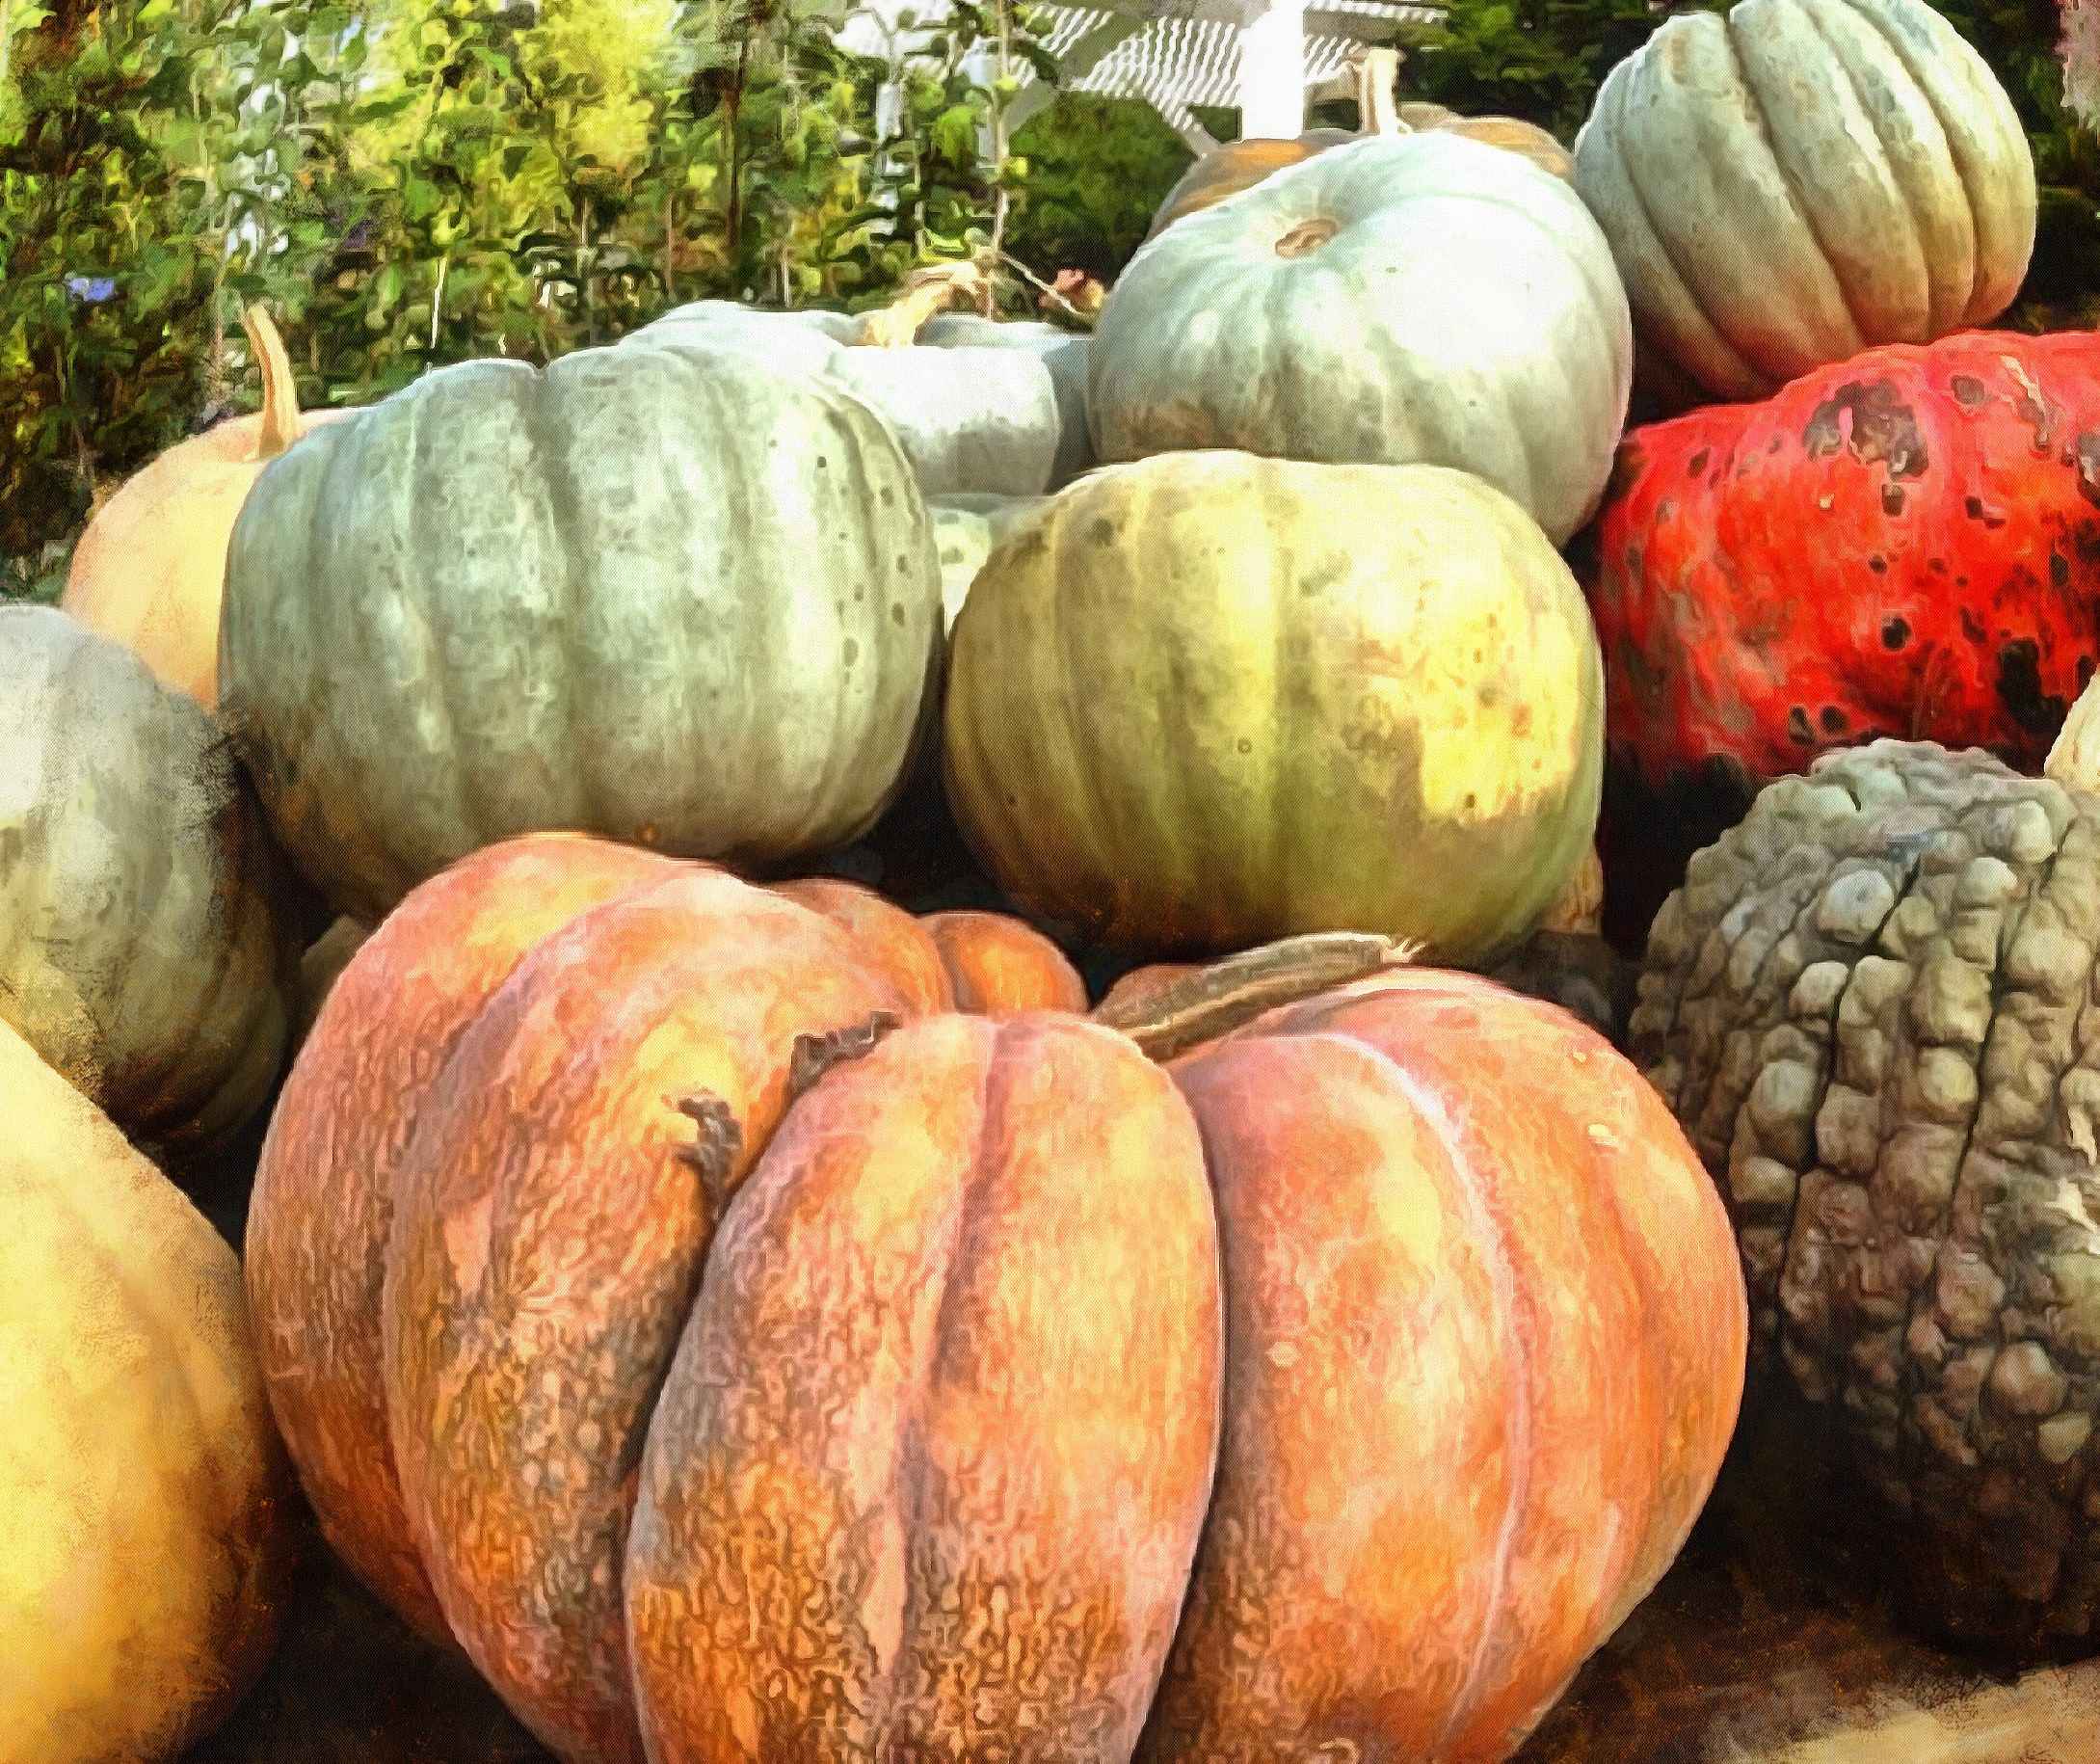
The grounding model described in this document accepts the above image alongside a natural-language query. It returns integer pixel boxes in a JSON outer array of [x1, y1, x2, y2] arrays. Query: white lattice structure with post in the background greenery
[[840, 0, 1443, 153]]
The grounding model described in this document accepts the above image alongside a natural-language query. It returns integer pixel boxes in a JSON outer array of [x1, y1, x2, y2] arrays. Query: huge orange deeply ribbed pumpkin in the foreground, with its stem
[[248, 836, 1745, 1764]]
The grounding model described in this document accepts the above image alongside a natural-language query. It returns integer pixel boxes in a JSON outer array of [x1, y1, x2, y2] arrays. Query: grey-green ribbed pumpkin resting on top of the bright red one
[[1575, 0, 2034, 399]]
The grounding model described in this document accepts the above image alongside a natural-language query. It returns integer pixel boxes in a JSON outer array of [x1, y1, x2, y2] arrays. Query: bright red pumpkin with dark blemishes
[[1590, 332, 2100, 948]]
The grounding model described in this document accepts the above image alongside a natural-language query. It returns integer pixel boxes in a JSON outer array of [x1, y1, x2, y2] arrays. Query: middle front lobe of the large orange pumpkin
[[625, 1014, 1224, 1764]]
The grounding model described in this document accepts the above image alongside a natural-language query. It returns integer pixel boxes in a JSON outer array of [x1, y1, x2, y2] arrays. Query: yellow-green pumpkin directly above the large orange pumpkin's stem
[[943, 447, 1603, 964]]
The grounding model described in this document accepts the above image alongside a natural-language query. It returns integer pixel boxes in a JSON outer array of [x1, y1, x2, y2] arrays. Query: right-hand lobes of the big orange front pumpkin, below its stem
[[1138, 973, 1747, 1764]]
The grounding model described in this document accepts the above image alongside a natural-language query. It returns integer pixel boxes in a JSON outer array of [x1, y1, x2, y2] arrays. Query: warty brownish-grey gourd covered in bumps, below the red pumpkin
[[1632, 741, 2100, 1643]]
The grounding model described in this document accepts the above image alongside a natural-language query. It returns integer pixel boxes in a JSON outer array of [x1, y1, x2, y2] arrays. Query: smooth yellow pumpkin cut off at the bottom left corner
[[0, 1023, 294, 1764]]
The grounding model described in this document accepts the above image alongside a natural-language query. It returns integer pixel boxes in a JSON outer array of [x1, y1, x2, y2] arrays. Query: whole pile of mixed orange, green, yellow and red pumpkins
[[12, 0, 2100, 1764]]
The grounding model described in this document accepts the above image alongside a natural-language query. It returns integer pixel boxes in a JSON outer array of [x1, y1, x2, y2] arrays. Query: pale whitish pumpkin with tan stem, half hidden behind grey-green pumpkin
[[636, 262, 1094, 495]]
